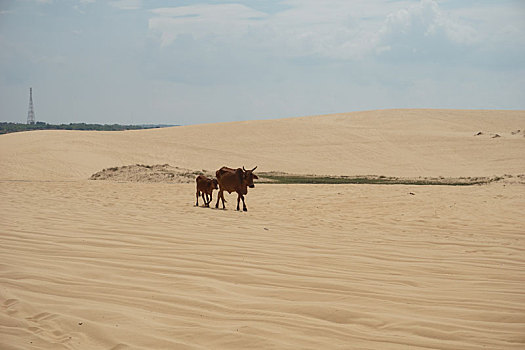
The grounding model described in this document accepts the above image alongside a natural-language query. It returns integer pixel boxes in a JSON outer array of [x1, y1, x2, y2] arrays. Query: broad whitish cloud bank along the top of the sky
[[149, 0, 479, 60]]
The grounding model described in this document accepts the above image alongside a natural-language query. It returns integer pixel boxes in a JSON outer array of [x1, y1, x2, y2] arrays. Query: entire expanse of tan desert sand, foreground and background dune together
[[0, 110, 525, 349]]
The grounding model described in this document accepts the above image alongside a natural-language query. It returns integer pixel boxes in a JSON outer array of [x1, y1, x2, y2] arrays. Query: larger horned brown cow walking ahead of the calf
[[215, 166, 258, 211]]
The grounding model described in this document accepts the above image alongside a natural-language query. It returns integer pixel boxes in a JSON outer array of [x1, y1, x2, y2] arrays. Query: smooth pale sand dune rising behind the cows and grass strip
[[0, 110, 525, 180]]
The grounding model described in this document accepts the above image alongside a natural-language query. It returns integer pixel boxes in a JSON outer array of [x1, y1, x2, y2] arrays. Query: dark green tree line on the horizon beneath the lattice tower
[[0, 122, 174, 134]]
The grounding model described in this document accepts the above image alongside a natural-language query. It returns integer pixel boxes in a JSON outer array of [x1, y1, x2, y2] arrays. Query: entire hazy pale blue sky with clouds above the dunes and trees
[[0, 0, 525, 125]]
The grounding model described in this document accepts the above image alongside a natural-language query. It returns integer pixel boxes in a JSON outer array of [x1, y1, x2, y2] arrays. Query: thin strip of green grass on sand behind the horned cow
[[259, 173, 502, 186]]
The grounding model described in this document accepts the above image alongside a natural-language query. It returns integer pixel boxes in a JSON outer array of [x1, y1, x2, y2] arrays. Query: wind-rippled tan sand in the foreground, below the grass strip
[[0, 181, 525, 350]]
